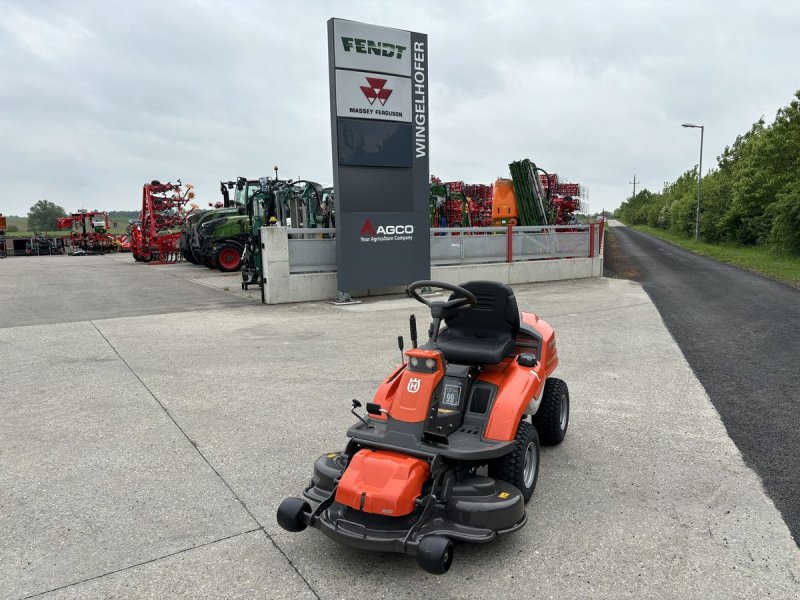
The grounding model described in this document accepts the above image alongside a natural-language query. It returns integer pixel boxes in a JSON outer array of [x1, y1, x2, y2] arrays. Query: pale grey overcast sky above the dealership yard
[[0, 0, 800, 214]]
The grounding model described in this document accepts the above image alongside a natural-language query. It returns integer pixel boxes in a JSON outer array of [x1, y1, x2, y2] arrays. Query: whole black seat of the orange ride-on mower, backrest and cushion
[[436, 281, 519, 365]]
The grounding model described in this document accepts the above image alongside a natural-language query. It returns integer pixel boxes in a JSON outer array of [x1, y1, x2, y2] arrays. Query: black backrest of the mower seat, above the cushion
[[445, 281, 519, 337]]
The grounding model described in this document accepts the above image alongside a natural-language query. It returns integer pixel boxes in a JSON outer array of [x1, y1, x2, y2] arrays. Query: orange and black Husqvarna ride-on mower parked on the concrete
[[277, 281, 569, 574]]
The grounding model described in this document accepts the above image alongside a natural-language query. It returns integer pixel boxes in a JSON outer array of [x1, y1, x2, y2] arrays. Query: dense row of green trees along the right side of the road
[[614, 91, 800, 256]]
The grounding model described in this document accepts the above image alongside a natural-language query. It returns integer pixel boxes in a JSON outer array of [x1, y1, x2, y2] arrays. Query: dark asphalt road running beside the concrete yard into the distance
[[610, 227, 800, 545]]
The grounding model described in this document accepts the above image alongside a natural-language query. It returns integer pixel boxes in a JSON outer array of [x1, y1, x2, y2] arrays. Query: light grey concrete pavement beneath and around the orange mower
[[0, 257, 800, 598]]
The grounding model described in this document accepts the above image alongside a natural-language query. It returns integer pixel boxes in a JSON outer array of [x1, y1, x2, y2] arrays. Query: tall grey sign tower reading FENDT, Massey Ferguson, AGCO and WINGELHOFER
[[328, 19, 430, 297]]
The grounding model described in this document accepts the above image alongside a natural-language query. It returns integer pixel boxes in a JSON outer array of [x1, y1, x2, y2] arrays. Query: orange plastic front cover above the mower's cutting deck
[[336, 449, 430, 517]]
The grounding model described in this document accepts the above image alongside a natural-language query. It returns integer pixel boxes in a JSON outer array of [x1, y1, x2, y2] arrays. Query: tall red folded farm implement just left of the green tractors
[[128, 179, 194, 264]]
